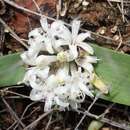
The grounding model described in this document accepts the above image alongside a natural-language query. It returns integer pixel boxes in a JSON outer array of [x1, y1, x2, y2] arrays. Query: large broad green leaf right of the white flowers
[[93, 45, 130, 106]]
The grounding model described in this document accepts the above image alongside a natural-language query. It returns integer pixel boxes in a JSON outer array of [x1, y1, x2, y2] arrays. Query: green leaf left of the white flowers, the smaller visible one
[[0, 53, 25, 87]]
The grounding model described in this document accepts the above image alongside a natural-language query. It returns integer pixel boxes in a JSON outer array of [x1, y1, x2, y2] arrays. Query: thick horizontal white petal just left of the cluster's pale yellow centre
[[36, 55, 57, 67]]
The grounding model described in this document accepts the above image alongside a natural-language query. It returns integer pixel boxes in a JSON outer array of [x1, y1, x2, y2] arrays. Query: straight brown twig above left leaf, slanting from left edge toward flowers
[[0, 18, 28, 48]]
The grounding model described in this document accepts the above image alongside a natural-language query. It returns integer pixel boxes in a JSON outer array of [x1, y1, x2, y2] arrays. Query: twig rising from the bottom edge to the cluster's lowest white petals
[[23, 110, 53, 130]]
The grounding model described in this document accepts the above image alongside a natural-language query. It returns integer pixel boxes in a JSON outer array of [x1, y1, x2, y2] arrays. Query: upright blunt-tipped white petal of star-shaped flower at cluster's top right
[[72, 20, 80, 40]]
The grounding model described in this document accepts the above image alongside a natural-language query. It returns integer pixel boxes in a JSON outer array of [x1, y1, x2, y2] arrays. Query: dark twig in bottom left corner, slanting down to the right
[[2, 97, 25, 128]]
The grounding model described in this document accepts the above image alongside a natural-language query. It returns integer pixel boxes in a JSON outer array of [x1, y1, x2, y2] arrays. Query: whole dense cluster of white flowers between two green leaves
[[21, 18, 98, 111]]
